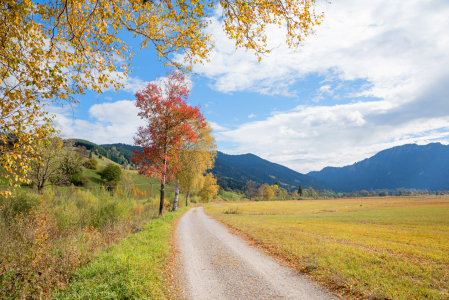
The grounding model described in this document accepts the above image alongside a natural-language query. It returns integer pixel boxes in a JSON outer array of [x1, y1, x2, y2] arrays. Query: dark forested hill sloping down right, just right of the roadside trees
[[212, 151, 333, 190]]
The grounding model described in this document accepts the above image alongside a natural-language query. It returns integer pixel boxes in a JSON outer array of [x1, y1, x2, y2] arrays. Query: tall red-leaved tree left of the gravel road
[[133, 73, 206, 215]]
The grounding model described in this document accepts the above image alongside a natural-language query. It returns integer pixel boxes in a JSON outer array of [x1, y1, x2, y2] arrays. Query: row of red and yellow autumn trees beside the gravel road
[[132, 72, 218, 214]]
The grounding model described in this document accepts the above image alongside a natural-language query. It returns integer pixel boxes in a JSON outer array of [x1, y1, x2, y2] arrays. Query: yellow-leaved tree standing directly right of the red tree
[[173, 122, 217, 210]]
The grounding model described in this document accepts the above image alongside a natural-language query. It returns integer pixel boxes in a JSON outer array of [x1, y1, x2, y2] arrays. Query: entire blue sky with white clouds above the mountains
[[50, 0, 449, 173]]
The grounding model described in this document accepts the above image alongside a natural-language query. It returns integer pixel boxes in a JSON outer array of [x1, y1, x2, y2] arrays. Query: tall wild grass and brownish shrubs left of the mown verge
[[0, 187, 173, 299]]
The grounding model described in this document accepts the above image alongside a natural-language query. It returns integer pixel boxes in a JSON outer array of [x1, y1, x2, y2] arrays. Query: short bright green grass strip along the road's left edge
[[54, 208, 187, 299]]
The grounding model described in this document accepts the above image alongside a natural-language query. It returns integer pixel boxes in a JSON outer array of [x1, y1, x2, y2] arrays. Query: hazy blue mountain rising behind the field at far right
[[307, 143, 449, 191]]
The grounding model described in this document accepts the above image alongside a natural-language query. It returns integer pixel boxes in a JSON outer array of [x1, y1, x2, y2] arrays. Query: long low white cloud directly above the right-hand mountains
[[217, 101, 449, 173]]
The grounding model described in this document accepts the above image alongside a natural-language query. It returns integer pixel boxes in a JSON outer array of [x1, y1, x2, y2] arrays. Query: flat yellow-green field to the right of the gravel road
[[206, 197, 449, 299]]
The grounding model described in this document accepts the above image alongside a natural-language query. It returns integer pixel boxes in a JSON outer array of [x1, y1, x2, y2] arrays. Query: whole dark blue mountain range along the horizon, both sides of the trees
[[74, 140, 449, 192]]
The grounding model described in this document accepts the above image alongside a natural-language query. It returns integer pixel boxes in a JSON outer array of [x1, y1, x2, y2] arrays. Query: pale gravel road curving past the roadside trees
[[176, 207, 339, 300]]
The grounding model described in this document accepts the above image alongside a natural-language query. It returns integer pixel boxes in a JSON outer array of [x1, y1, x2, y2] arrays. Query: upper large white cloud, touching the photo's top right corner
[[185, 0, 449, 101]]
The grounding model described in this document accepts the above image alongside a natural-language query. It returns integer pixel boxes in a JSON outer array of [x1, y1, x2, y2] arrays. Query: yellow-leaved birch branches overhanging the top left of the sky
[[0, 0, 324, 195]]
